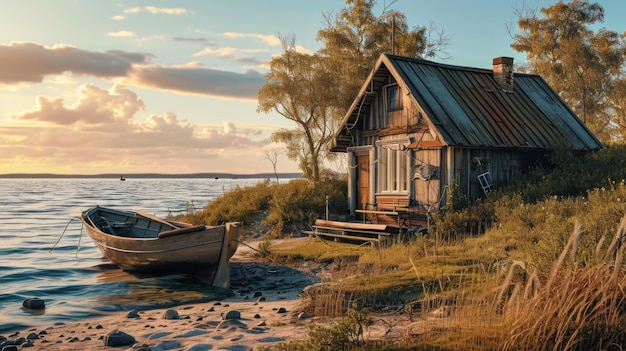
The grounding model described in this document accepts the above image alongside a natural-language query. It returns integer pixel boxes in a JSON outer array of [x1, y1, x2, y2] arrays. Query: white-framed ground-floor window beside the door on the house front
[[377, 144, 410, 193]]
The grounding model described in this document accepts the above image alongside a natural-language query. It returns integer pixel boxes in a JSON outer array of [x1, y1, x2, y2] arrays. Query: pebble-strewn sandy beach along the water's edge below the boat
[[0, 238, 413, 351]]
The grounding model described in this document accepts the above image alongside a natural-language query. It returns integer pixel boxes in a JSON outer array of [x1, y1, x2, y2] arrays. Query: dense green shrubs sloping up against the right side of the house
[[429, 145, 626, 247]]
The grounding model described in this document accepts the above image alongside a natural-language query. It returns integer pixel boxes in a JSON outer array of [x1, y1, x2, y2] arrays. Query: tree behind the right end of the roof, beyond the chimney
[[511, 0, 626, 141]]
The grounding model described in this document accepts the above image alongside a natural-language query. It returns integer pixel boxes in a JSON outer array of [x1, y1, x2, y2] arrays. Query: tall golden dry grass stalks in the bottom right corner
[[496, 217, 626, 350]]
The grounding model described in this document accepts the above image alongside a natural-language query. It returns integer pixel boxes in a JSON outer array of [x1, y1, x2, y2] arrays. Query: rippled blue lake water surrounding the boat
[[0, 179, 261, 333]]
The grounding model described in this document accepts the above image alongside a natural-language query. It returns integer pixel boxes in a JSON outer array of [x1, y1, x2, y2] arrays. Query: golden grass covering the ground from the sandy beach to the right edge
[[271, 208, 626, 350]]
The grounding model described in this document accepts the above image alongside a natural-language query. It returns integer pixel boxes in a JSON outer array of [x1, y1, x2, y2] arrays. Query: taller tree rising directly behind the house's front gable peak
[[317, 0, 448, 113]]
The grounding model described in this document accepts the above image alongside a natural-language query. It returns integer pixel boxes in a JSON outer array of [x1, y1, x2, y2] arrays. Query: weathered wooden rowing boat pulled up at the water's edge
[[81, 206, 242, 288]]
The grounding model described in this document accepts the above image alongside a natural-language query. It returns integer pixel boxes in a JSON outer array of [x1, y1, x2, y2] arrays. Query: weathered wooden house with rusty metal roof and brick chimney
[[333, 55, 602, 227]]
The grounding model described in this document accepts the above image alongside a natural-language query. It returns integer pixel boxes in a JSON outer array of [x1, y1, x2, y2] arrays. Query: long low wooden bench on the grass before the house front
[[303, 219, 393, 245]]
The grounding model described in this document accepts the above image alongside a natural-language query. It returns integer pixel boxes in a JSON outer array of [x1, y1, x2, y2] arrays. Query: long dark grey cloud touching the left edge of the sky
[[0, 42, 149, 85]]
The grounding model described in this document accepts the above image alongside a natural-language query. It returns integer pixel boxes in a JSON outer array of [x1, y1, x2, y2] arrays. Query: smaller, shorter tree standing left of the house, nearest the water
[[258, 37, 338, 181]]
